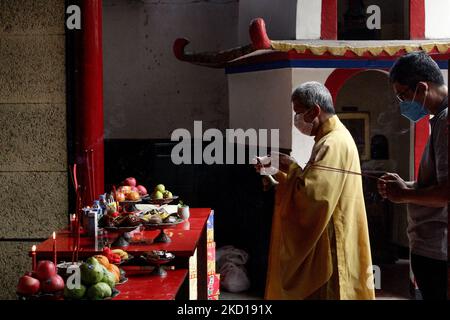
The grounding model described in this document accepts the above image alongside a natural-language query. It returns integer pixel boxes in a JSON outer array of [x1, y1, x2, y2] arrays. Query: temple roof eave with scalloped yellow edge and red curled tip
[[173, 18, 450, 68]]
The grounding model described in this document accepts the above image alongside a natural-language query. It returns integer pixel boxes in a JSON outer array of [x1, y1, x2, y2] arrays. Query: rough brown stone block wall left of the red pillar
[[0, 0, 68, 299]]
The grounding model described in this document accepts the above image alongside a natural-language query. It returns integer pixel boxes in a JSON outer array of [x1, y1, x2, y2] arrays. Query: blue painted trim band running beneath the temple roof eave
[[225, 60, 448, 74]]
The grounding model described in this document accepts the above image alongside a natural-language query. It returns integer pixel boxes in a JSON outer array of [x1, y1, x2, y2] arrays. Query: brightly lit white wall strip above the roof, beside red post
[[295, 0, 322, 39]]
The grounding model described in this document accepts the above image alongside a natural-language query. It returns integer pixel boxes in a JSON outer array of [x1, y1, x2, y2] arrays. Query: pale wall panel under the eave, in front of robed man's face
[[228, 69, 292, 149]]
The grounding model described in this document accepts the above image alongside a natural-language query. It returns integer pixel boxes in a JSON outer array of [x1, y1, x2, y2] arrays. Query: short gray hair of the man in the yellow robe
[[291, 81, 335, 114]]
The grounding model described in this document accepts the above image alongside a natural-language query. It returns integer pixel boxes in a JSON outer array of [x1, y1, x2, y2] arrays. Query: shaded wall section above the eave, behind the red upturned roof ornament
[[239, 0, 298, 45]]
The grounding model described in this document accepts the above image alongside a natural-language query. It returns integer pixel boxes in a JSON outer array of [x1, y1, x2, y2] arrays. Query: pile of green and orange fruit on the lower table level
[[64, 255, 120, 300]]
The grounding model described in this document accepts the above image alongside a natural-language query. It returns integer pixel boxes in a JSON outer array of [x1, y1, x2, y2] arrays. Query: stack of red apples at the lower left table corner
[[17, 260, 64, 297]]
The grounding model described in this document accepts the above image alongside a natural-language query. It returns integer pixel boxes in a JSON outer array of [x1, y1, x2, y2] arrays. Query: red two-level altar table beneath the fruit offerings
[[29, 208, 211, 300]]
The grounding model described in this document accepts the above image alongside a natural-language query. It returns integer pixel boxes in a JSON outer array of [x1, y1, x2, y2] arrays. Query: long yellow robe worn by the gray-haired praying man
[[265, 116, 375, 300]]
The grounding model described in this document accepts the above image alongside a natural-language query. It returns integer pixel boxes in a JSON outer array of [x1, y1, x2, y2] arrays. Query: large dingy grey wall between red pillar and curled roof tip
[[103, 0, 238, 139]]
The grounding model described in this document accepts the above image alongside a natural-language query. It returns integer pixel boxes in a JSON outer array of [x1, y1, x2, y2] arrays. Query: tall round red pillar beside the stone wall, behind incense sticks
[[74, 0, 104, 205]]
